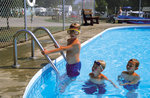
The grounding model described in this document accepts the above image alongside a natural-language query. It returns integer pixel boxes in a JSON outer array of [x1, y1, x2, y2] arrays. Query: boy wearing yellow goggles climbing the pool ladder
[[42, 23, 81, 92]]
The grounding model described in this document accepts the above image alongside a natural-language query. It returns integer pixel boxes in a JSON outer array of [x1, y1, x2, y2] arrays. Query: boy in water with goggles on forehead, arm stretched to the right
[[83, 60, 118, 94]]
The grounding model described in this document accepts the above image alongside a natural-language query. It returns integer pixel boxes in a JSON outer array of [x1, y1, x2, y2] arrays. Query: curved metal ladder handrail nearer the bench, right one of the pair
[[31, 27, 67, 62]]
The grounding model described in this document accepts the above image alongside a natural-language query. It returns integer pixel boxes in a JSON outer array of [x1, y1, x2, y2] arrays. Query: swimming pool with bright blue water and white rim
[[23, 26, 150, 98]]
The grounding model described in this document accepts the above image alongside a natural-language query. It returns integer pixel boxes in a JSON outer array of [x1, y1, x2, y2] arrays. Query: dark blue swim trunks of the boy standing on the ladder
[[66, 62, 81, 77]]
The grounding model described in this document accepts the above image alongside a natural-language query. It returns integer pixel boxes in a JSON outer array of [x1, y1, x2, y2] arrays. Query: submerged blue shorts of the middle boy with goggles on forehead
[[82, 81, 106, 94]]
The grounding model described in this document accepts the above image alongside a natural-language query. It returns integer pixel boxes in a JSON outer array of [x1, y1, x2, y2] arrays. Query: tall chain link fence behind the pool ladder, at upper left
[[0, 0, 95, 48]]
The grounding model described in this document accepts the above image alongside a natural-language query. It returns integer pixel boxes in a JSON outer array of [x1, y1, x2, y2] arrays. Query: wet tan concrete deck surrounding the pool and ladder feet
[[0, 22, 143, 98]]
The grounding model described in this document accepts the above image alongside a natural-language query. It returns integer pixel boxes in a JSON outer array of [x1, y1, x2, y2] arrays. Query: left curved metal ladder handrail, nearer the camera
[[13, 29, 59, 74]]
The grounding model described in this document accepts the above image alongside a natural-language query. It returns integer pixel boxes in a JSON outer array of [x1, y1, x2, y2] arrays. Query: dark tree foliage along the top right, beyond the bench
[[95, 0, 150, 14]]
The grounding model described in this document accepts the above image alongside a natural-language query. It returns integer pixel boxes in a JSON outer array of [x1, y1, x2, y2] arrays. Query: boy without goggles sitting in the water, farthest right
[[118, 59, 140, 91]]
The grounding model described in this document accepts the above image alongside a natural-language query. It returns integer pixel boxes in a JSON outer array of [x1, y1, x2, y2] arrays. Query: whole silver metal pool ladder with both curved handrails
[[12, 27, 67, 73]]
